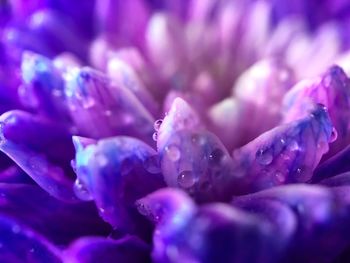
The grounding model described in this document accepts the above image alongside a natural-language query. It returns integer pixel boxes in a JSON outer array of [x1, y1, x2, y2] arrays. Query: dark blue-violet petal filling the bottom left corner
[[0, 215, 62, 263]]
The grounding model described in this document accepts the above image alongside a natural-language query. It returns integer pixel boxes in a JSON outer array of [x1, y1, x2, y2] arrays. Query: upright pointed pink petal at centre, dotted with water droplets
[[157, 98, 234, 202]]
